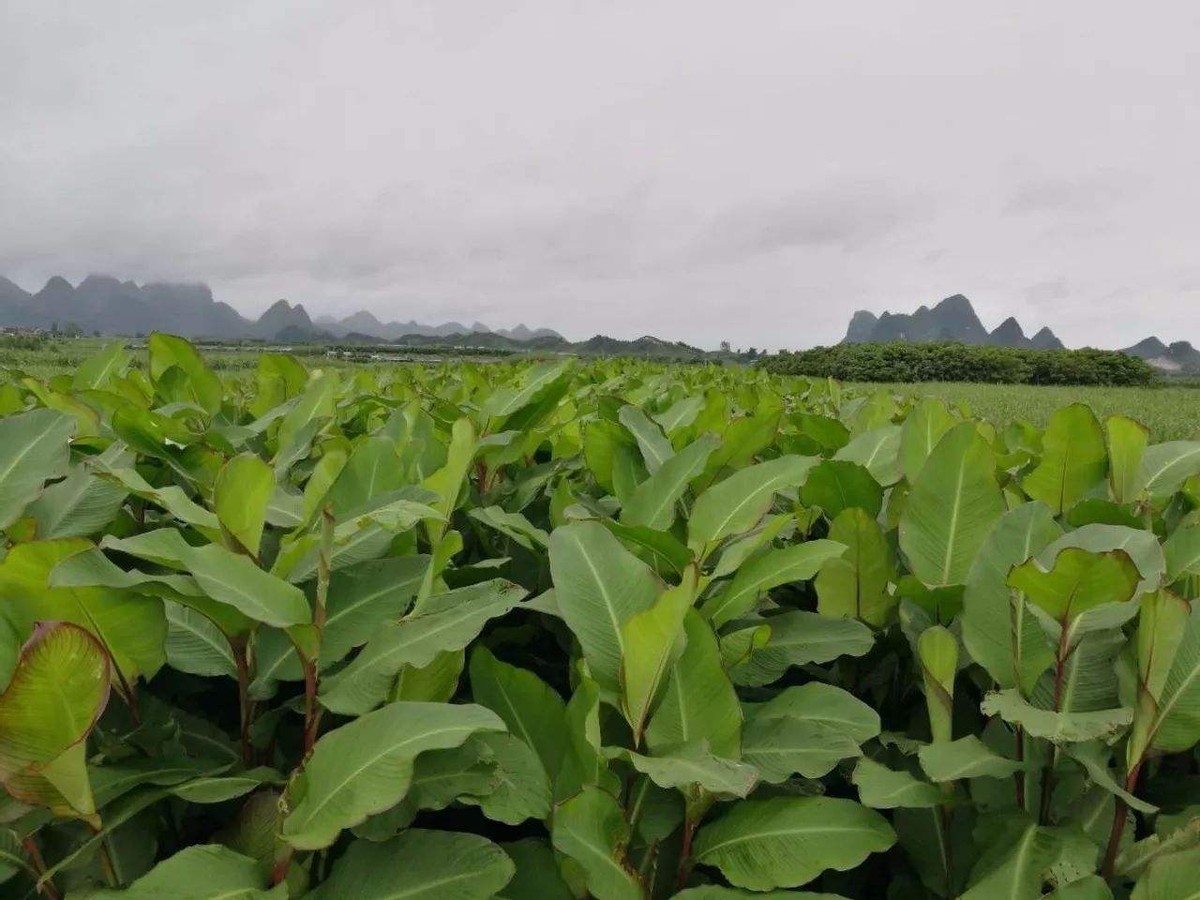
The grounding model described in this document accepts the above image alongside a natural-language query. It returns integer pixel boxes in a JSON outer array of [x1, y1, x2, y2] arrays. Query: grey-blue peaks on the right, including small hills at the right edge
[[842, 294, 1200, 373]]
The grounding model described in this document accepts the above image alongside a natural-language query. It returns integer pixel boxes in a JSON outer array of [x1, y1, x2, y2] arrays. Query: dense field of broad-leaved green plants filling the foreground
[[0, 335, 1200, 900]]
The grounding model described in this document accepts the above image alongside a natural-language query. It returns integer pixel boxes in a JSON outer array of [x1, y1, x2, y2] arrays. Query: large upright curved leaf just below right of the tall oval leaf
[[960, 503, 1062, 695]]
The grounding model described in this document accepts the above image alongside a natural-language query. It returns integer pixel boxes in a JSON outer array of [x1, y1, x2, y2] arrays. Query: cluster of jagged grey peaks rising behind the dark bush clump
[[842, 294, 1063, 349]]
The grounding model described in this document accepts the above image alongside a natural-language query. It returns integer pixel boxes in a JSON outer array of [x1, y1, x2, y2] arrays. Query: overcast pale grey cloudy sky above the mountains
[[0, 0, 1200, 348]]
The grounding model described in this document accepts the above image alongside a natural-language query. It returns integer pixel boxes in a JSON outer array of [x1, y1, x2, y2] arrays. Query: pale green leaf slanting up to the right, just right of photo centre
[[688, 456, 820, 554]]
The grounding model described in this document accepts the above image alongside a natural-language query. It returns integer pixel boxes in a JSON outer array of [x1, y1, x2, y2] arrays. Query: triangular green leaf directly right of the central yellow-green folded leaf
[[646, 611, 742, 760]]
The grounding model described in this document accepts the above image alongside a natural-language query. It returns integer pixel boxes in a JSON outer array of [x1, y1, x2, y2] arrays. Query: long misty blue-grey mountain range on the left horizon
[[0, 275, 563, 342]]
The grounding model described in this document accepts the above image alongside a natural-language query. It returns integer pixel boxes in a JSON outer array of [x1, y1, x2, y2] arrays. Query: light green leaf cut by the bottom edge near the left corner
[[90, 844, 287, 900]]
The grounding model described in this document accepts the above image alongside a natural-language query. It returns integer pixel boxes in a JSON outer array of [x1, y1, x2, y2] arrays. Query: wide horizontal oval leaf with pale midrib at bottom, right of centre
[[692, 797, 895, 890]]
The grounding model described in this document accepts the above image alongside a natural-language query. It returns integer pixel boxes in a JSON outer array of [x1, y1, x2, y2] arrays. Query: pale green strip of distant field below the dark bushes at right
[[873, 382, 1200, 442]]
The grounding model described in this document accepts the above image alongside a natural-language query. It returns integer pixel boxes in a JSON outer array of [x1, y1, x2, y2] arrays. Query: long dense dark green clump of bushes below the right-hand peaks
[[760, 342, 1158, 385]]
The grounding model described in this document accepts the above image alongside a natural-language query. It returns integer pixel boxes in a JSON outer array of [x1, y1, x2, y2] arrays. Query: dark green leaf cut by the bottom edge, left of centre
[[307, 828, 515, 900]]
